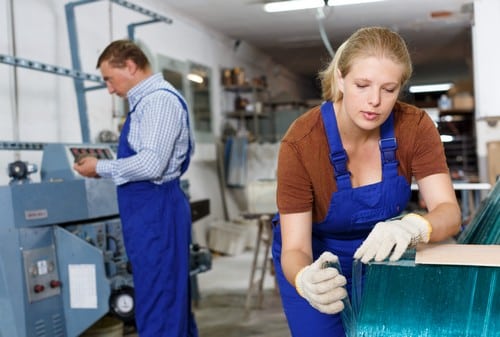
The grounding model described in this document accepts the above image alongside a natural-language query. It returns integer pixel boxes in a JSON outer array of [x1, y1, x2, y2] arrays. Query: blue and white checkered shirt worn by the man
[[96, 73, 194, 185]]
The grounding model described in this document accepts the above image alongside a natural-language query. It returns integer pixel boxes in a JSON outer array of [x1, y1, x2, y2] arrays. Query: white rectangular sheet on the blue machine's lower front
[[68, 264, 97, 309]]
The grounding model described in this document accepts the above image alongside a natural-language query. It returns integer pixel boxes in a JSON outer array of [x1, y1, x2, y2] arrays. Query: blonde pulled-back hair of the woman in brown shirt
[[318, 27, 413, 102]]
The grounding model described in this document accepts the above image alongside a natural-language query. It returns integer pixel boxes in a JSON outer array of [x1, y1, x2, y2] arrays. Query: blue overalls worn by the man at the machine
[[117, 89, 198, 337]]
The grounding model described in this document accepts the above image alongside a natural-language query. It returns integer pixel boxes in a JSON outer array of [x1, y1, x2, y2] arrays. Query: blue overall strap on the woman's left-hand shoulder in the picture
[[321, 101, 352, 190]]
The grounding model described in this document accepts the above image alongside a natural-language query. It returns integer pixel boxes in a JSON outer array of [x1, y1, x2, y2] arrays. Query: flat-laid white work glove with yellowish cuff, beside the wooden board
[[354, 213, 432, 263]]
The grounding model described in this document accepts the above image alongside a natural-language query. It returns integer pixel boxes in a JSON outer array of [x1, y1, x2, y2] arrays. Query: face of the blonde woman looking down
[[338, 56, 404, 131]]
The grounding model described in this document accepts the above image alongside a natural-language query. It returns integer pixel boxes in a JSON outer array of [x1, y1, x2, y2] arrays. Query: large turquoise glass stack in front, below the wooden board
[[346, 260, 500, 337]]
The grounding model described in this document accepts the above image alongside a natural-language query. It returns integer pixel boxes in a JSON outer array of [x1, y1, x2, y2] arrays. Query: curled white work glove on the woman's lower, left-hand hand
[[295, 252, 347, 314]]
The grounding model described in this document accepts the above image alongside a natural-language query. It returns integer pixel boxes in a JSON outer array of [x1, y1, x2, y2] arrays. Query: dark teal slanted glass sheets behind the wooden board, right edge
[[457, 180, 500, 243]]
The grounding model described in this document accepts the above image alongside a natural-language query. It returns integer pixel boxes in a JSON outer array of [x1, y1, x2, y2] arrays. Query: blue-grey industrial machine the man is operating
[[0, 143, 211, 337]]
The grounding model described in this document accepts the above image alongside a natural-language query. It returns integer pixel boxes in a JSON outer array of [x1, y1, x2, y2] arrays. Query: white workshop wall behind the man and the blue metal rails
[[0, 0, 308, 226]]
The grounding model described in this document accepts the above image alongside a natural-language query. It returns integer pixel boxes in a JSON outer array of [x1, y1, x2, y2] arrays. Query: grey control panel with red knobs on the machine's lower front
[[23, 245, 62, 303]]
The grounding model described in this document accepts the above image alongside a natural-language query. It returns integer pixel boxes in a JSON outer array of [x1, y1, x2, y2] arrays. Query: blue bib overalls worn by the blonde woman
[[272, 102, 411, 337]]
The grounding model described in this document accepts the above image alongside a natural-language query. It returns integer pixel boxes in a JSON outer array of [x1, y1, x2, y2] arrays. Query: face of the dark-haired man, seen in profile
[[99, 61, 134, 98]]
